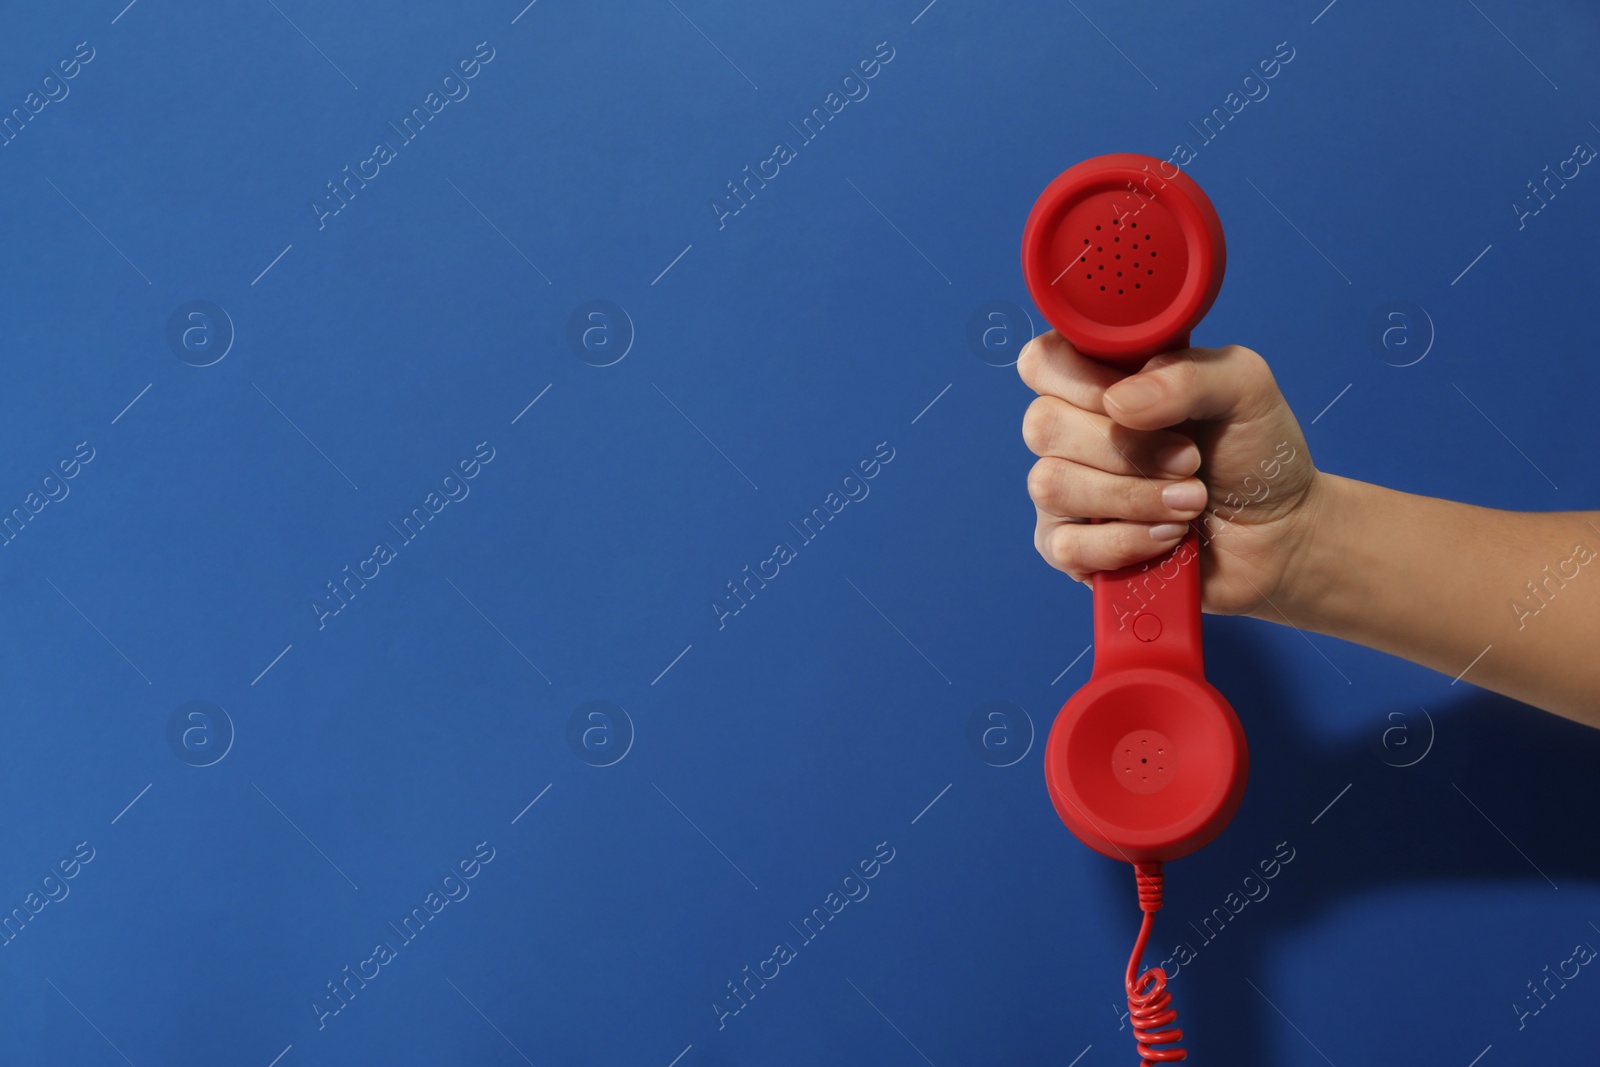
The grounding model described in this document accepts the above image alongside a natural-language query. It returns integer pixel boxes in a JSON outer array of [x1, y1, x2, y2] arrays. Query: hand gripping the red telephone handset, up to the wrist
[[1016, 331, 1322, 614]]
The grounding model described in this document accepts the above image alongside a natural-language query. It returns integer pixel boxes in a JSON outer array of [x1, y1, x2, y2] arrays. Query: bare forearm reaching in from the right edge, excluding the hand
[[1254, 474, 1600, 726]]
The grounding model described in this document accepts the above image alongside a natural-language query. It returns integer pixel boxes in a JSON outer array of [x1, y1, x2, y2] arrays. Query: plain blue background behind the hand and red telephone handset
[[0, 0, 1600, 1067]]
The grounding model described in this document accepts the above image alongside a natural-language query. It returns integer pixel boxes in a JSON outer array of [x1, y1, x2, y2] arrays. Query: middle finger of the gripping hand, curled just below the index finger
[[1022, 395, 1200, 477]]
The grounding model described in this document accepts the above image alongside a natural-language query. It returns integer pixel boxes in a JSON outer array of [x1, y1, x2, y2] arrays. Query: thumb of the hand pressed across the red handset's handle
[[1100, 344, 1283, 430]]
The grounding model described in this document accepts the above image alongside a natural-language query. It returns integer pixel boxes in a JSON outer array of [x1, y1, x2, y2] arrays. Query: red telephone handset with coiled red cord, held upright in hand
[[1022, 154, 1250, 1062]]
